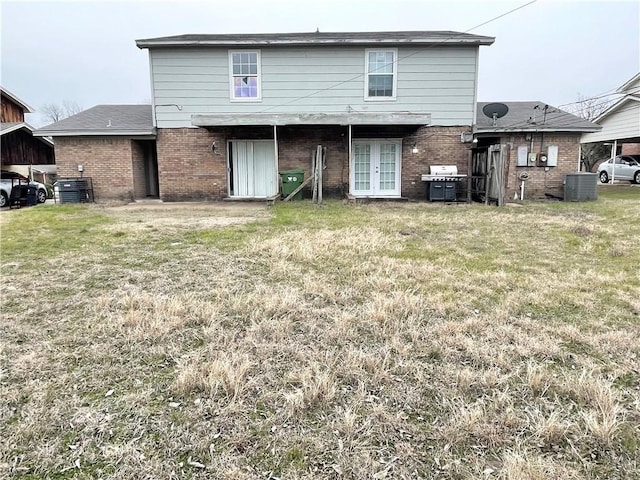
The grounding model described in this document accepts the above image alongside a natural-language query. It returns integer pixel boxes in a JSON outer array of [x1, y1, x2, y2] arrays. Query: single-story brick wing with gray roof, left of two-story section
[[36, 105, 158, 200]]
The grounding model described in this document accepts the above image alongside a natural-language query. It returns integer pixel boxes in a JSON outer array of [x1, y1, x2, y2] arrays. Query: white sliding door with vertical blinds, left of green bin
[[229, 140, 278, 198]]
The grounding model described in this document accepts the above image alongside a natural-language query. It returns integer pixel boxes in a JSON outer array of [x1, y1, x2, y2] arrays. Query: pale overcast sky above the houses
[[0, 0, 640, 126]]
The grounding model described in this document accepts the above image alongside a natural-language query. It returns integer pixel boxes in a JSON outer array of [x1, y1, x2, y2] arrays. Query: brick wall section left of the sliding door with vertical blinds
[[157, 128, 228, 201]]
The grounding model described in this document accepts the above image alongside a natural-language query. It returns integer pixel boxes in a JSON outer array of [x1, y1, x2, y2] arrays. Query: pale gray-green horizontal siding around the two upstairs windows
[[150, 47, 478, 128]]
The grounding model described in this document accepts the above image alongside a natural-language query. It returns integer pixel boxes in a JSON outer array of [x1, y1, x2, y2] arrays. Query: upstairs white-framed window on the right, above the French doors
[[365, 49, 398, 100]]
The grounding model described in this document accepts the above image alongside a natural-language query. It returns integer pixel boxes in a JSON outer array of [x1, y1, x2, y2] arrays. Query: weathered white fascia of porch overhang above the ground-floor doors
[[191, 112, 431, 127]]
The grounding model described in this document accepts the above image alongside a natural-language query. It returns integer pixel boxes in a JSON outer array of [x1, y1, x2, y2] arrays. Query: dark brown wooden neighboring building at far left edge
[[0, 87, 55, 180]]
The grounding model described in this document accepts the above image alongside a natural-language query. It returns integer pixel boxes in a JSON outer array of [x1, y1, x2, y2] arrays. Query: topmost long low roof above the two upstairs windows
[[136, 31, 495, 48]]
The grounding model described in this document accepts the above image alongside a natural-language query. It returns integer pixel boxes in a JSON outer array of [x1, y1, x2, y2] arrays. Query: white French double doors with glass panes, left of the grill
[[350, 140, 402, 197]]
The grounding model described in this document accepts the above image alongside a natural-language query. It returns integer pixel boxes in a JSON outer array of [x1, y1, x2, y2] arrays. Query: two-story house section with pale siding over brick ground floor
[[136, 31, 494, 200]]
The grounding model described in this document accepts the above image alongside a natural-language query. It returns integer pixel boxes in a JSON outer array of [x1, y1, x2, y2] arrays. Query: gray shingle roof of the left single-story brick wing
[[34, 105, 155, 137]]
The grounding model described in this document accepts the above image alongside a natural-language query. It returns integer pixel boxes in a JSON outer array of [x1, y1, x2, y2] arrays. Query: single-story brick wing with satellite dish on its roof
[[474, 102, 601, 199]]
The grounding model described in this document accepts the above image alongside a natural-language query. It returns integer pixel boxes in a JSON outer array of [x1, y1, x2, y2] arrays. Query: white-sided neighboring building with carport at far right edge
[[580, 73, 640, 157]]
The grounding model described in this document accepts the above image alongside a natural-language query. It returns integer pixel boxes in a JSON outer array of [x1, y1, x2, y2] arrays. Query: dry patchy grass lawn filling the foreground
[[0, 186, 640, 480]]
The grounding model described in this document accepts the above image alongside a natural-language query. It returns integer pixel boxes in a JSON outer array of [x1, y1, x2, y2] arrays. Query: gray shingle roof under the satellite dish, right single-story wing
[[474, 102, 602, 133]]
